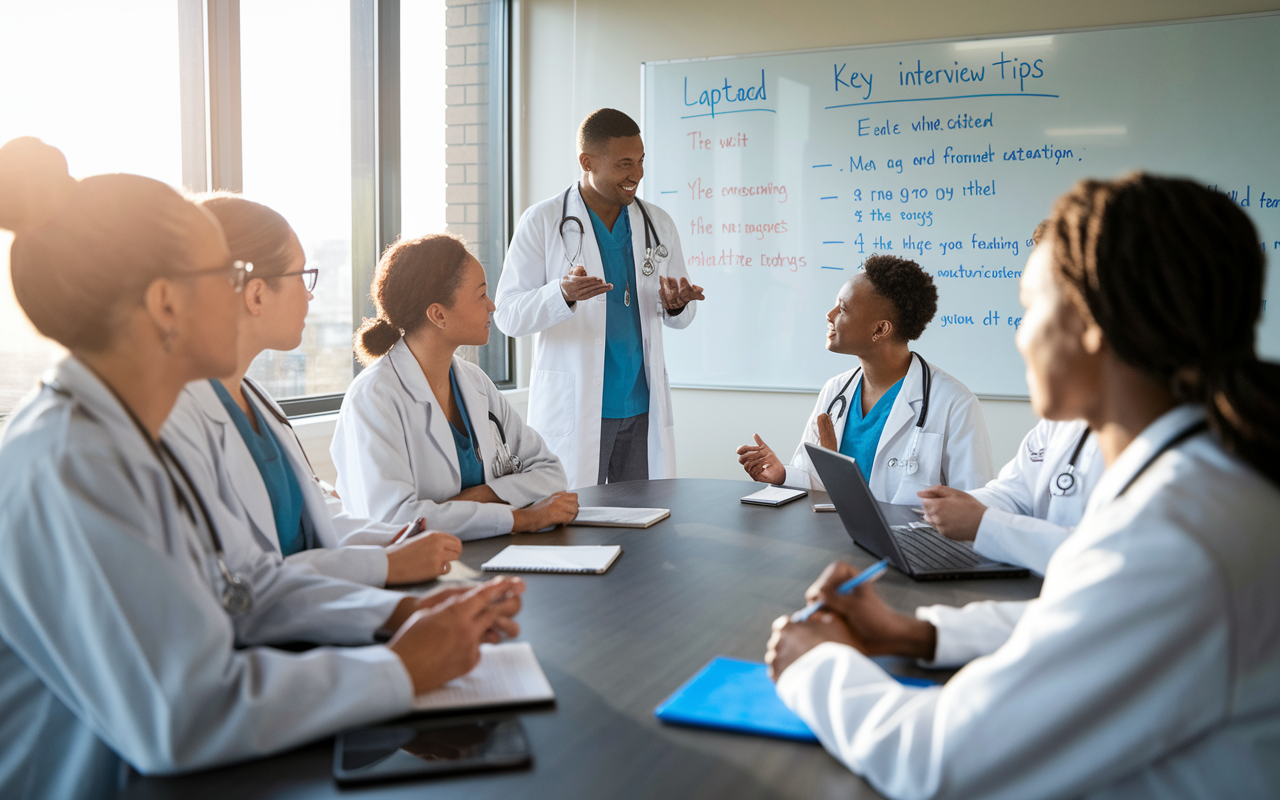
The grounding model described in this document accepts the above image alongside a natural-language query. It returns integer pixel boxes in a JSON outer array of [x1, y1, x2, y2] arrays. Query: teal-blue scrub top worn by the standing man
[[586, 209, 649, 420]]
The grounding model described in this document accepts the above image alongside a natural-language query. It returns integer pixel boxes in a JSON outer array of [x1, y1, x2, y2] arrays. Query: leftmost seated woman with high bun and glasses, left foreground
[[0, 138, 521, 800]]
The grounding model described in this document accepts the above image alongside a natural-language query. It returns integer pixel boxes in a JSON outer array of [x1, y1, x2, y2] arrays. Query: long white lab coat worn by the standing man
[[493, 184, 698, 486]]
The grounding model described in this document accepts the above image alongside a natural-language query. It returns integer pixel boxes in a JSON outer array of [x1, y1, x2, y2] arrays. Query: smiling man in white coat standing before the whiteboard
[[494, 109, 703, 488]]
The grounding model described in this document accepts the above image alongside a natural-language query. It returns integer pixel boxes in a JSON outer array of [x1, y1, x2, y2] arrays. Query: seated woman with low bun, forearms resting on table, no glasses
[[330, 234, 577, 539]]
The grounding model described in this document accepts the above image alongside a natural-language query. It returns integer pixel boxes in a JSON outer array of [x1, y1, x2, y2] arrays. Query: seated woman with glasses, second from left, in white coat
[[164, 193, 462, 586]]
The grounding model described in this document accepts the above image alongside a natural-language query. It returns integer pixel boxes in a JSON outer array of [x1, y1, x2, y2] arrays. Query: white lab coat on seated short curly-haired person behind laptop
[[783, 358, 996, 506]]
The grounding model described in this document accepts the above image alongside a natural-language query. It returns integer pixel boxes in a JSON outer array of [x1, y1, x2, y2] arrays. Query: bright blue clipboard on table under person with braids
[[653, 655, 934, 742]]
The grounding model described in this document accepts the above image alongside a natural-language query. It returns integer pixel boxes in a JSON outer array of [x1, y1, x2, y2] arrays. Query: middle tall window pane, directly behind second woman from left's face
[[239, 0, 355, 398]]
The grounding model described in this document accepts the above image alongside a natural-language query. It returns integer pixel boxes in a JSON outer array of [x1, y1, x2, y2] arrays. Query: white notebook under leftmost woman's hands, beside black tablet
[[413, 641, 556, 712]]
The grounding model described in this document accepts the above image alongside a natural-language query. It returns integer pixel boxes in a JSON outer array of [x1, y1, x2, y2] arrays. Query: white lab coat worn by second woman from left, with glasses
[[164, 378, 401, 586]]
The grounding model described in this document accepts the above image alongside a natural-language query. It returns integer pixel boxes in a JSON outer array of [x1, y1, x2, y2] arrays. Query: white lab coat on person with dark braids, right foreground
[[778, 406, 1280, 800]]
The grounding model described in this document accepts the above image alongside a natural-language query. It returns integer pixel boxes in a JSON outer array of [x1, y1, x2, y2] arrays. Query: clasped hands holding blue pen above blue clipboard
[[764, 561, 937, 681]]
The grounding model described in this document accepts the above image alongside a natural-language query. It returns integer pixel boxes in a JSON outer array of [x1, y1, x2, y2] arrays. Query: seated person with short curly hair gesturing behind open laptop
[[737, 255, 995, 506]]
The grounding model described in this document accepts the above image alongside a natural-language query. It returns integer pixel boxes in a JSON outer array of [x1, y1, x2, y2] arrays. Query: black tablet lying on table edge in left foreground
[[333, 717, 532, 785]]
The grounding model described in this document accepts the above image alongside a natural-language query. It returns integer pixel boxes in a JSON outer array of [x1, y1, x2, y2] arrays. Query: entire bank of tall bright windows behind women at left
[[0, 0, 513, 415]]
